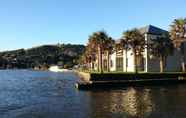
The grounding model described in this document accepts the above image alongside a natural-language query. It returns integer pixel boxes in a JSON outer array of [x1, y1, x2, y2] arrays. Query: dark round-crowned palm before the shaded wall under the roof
[[149, 35, 174, 72]]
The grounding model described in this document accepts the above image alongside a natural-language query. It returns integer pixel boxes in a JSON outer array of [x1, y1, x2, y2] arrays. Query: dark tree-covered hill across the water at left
[[0, 44, 85, 69]]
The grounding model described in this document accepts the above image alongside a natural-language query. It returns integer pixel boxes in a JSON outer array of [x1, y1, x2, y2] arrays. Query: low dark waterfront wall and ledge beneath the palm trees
[[75, 72, 186, 90]]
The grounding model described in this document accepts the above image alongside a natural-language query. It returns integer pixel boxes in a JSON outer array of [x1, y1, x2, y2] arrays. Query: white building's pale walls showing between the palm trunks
[[107, 34, 186, 72]]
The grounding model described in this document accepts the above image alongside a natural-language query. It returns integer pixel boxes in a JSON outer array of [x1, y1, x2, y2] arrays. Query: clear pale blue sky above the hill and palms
[[0, 0, 186, 51]]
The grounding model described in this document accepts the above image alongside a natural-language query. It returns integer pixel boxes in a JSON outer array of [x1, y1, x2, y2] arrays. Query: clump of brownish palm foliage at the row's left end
[[81, 31, 115, 72]]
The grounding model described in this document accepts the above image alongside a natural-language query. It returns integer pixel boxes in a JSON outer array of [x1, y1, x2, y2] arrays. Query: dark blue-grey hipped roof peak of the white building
[[139, 25, 168, 35]]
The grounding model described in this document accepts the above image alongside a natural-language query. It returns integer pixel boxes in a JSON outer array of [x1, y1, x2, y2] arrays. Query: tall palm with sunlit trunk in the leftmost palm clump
[[89, 31, 109, 73]]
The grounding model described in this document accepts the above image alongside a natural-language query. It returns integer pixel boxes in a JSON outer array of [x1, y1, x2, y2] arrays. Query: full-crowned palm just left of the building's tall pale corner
[[123, 28, 146, 73]]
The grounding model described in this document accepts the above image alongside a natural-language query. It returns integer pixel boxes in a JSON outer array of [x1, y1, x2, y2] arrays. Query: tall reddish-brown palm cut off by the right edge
[[170, 18, 186, 72]]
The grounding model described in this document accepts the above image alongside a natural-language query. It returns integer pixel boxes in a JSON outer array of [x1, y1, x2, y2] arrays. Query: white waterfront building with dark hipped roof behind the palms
[[92, 25, 186, 72]]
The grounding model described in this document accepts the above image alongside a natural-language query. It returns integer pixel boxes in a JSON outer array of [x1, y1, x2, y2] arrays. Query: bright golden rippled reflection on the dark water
[[123, 88, 154, 118]]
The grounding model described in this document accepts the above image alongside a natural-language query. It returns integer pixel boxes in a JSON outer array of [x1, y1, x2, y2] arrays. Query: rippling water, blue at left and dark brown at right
[[0, 70, 186, 118]]
